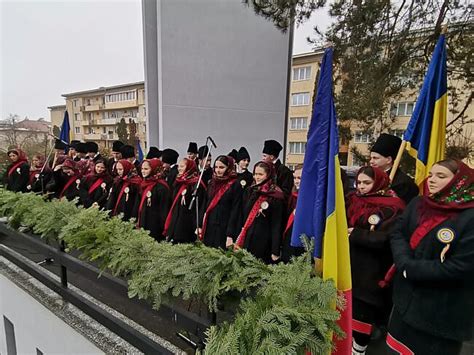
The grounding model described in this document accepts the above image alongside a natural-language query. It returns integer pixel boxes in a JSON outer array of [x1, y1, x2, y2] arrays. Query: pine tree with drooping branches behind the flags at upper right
[[312, 0, 474, 143]]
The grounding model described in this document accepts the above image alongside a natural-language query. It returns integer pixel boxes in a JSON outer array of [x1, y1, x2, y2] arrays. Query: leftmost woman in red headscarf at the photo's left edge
[[3, 149, 30, 192]]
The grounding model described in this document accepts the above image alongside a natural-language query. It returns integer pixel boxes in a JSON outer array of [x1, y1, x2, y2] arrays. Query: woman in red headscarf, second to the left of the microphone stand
[[133, 158, 171, 241]]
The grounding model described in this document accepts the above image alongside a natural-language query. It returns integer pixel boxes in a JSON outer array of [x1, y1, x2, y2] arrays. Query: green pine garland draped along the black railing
[[0, 189, 343, 354]]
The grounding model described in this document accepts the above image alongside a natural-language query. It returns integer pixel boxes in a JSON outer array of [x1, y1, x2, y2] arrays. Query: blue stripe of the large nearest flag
[[291, 48, 339, 257]]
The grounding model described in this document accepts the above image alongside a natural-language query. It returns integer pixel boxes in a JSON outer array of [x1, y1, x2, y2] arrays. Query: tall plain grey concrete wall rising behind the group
[[142, 0, 290, 162]]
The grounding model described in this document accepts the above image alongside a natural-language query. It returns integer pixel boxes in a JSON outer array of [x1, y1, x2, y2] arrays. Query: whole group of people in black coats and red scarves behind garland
[[4, 134, 474, 355]]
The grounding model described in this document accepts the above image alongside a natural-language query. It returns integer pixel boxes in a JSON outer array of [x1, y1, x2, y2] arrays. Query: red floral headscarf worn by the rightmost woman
[[379, 161, 474, 287]]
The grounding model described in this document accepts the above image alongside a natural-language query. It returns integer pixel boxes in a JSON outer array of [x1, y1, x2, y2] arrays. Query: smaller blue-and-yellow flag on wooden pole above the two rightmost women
[[403, 34, 448, 186]]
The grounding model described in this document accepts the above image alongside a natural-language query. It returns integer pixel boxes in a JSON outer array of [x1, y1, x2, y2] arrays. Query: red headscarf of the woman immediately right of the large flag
[[347, 167, 405, 227]]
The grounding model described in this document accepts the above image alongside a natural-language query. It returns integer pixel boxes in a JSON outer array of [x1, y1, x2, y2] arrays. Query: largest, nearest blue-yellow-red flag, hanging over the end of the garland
[[291, 48, 352, 354]]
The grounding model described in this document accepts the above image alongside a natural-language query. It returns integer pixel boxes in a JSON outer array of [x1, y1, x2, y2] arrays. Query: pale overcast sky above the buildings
[[0, 0, 329, 119]]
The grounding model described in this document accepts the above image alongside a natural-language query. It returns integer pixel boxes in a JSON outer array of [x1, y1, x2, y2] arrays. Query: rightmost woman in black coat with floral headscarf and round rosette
[[387, 159, 474, 355]]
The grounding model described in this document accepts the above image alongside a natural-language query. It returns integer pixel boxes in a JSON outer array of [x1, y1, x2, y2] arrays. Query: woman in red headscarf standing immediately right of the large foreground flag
[[347, 166, 405, 354]]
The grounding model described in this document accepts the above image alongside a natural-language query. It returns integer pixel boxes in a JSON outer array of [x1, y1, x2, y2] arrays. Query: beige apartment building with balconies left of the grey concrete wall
[[57, 81, 146, 149]]
